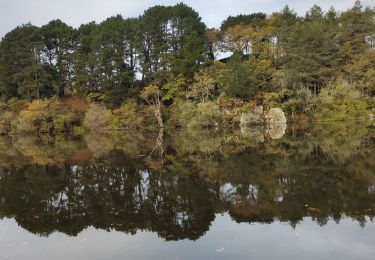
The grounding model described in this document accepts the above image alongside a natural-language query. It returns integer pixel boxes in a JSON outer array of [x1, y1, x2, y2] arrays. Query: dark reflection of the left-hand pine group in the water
[[0, 152, 214, 240]]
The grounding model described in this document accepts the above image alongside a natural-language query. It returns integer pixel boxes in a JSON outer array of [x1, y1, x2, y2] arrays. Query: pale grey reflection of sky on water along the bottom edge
[[0, 215, 375, 260]]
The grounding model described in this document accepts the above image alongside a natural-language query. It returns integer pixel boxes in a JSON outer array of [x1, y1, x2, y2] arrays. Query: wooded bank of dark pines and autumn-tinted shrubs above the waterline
[[0, 1, 375, 133]]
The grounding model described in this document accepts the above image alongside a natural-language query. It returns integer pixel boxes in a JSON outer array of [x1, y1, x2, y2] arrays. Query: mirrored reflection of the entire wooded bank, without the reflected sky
[[0, 124, 375, 240]]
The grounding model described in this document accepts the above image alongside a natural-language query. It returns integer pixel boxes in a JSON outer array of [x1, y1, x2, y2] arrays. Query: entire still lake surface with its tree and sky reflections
[[0, 123, 375, 260]]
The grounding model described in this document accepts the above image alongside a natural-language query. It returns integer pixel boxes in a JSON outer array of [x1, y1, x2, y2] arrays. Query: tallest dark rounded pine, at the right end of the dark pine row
[[137, 3, 207, 82]]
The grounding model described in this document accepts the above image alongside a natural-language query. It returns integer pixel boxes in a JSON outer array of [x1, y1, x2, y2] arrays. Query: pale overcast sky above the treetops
[[0, 0, 375, 37]]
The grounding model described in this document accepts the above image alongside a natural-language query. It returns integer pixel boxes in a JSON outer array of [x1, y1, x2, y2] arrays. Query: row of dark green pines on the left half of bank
[[0, 4, 208, 105]]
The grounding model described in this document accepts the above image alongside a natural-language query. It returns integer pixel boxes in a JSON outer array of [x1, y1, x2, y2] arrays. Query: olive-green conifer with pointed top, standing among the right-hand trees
[[281, 6, 338, 94]]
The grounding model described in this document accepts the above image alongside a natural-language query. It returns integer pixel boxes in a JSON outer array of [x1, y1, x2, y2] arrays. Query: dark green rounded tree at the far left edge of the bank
[[0, 24, 50, 101]]
